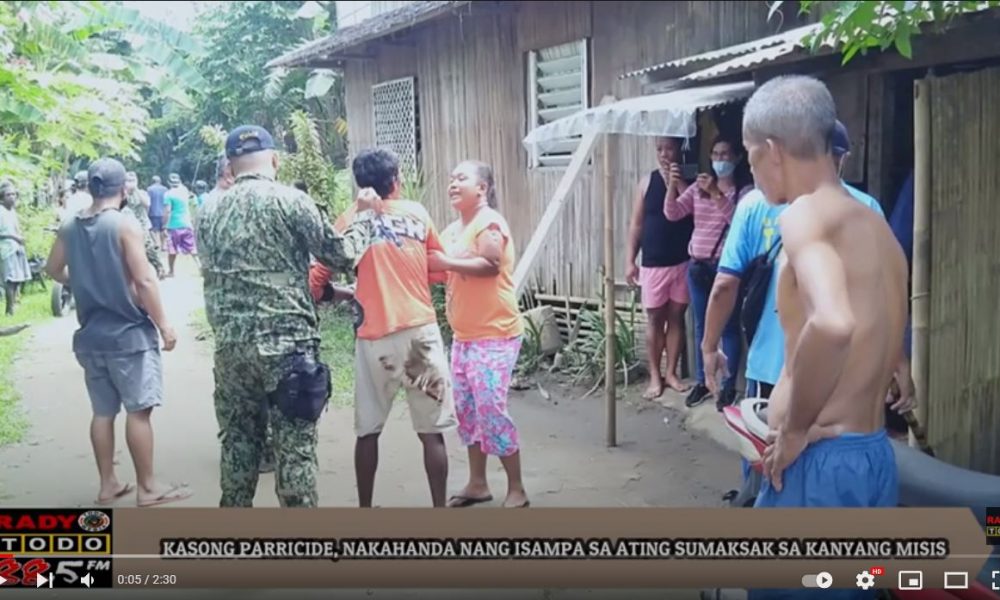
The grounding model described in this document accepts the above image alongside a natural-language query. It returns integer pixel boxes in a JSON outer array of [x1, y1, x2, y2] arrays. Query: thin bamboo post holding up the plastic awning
[[604, 133, 618, 447]]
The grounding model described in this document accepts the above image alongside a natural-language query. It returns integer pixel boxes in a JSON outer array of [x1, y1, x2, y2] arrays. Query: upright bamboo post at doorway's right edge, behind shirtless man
[[910, 79, 932, 445]]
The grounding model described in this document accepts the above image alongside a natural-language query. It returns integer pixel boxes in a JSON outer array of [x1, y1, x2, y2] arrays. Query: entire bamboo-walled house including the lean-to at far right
[[272, 1, 1000, 474]]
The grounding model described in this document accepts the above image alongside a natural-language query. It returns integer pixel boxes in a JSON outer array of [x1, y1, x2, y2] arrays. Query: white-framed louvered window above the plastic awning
[[528, 39, 590, 167]]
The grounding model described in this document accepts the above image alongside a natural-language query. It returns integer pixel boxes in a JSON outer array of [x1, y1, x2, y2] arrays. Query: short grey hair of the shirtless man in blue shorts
[[743, 75, 837, 160]]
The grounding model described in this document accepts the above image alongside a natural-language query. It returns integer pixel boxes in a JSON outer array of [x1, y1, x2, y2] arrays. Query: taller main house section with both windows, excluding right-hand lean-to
[[272, 1, 820, 298]]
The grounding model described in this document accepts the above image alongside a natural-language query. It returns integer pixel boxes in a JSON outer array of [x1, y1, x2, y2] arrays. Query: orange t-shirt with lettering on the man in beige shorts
[[334, 200, 444, 340]]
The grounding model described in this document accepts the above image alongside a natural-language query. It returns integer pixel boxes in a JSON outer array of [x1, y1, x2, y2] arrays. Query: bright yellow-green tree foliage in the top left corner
[[0, 1, 202, 188]]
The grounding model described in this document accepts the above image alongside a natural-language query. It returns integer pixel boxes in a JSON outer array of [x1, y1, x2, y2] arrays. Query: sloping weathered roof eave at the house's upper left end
[[267, 0, 470, 69]]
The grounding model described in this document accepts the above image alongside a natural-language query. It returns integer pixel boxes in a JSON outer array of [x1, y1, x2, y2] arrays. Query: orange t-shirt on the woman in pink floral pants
[[441, 208, 524, 342]]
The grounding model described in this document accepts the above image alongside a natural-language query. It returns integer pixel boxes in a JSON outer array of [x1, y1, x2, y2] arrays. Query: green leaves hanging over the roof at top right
[[769, 0, 1000, 64]]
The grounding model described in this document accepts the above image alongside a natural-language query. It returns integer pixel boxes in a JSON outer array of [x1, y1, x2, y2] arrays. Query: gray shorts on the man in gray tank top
[[76, 348, 163, 417]]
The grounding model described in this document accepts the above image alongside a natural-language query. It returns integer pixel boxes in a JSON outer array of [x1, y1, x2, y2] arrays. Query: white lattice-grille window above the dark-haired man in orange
[[372, 77, 420, 175]]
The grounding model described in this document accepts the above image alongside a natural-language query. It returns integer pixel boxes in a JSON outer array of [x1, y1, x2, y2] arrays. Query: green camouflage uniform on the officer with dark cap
[[198, 174, 372, 507]]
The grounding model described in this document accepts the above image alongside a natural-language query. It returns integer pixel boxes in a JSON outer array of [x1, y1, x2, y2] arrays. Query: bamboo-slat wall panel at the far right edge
[[927, 68, 1000, 474]]
